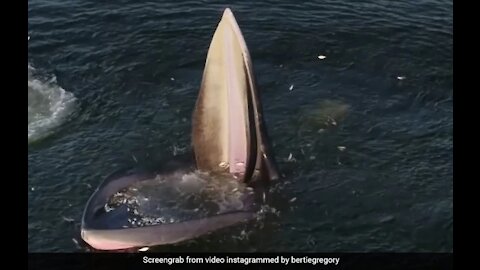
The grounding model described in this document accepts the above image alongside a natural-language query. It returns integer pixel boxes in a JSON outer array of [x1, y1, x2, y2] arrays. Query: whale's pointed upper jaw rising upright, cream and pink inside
[[192, 8, 277, 182]]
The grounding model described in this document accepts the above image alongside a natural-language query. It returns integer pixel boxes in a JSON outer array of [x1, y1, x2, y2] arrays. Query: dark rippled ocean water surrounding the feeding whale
[[28, 0, 453, 252]]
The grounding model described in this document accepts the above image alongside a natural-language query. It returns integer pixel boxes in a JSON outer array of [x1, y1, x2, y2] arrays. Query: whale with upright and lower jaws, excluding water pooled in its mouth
[[81, 8, 279, 250]]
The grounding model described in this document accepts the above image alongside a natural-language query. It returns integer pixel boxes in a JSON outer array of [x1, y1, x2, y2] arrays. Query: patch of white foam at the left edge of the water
[[28, 65, 76, 143]]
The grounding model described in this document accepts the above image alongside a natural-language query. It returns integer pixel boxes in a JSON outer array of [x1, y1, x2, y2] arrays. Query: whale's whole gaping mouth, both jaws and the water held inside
[[81, 9, 278, 253]]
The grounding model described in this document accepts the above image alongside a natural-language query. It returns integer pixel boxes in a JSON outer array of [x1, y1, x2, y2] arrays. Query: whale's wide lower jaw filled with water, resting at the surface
[[81, 169, 256, 250]]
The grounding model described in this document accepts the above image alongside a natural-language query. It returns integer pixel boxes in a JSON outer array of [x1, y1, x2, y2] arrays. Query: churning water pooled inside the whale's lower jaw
[[105, 171, 253, 228]]
